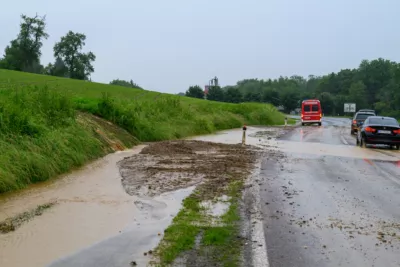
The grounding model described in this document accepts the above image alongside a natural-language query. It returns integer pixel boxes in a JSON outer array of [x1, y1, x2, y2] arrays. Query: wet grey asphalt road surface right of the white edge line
[[261, 118, 400, 267]]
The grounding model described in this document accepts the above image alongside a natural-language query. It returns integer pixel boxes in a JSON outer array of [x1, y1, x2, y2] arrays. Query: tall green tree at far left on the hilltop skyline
[[0, 14, 49, 73]]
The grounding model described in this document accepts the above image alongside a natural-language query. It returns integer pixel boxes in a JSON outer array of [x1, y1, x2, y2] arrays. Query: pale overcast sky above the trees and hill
[[0, 0, 400, 93]]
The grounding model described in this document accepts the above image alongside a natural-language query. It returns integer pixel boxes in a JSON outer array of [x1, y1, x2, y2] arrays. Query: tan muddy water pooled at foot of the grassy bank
[[0, 147, 147, 267]]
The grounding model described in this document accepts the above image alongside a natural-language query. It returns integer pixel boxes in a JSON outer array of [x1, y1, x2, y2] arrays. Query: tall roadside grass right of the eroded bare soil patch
[[77, 94, 284, 141]]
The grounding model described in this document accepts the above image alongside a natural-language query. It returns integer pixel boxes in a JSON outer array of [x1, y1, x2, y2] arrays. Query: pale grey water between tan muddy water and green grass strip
[[47, 186, 194, 267]]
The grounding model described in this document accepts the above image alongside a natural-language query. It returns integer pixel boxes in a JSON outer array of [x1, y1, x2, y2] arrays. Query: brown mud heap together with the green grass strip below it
[[119, 140, 261, 267]]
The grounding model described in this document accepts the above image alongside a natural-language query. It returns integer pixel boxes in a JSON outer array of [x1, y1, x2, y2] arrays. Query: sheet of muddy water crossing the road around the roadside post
[[192, 126, 400, 162]]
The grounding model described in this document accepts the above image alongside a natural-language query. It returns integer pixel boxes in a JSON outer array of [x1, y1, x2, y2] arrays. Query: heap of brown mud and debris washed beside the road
[[118, 140, 258, 200]]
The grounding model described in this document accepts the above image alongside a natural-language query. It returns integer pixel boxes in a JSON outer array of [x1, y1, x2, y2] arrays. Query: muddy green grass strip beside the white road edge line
[[153, 181, 243, 266]]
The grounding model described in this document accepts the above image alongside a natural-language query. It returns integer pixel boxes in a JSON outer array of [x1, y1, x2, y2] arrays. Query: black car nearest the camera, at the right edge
[[357, 116, 400, 150]]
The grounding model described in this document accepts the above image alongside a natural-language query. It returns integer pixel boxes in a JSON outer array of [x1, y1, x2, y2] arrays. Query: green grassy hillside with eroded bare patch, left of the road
[[0, 70, 284, 193]]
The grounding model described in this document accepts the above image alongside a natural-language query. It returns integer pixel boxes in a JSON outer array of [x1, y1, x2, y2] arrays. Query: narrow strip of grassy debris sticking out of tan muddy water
[[0, 202, 56, 234]]
